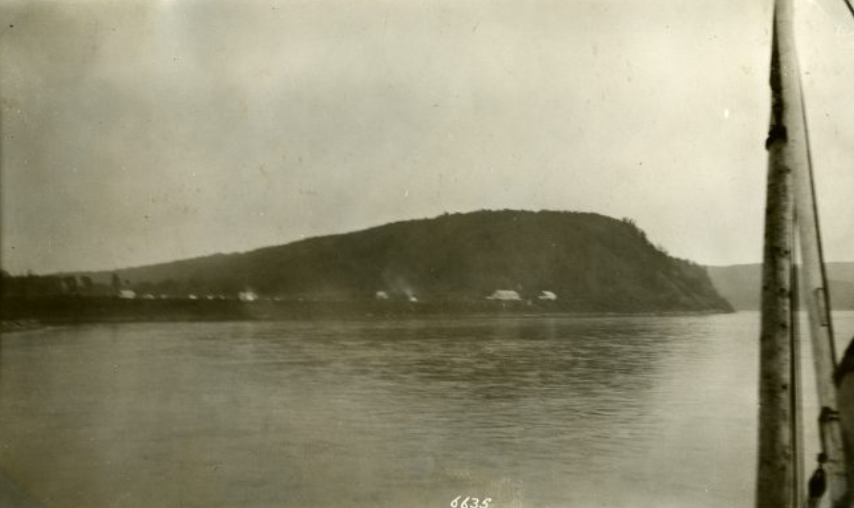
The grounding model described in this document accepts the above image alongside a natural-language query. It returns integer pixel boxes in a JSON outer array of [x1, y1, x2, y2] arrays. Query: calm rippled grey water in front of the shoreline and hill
[[0, 313, 854, 508]]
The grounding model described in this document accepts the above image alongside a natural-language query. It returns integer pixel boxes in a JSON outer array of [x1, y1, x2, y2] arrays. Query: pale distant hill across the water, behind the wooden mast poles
[[708, 263, 854, 310]]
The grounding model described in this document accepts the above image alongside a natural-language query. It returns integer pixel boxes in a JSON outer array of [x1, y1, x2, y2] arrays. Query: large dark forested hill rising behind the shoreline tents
[[72, 211, 730, 312]]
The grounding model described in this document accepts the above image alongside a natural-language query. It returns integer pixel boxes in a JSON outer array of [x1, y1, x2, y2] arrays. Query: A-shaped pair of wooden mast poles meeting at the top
[[756, 0, 848, 508]]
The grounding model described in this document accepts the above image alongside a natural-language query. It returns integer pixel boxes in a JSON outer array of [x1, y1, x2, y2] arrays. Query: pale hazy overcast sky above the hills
[[0, 0, 854, 273]]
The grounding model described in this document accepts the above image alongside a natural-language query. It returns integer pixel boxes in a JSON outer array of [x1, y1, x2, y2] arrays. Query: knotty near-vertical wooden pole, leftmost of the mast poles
[[756, 0, 799, 508]]
